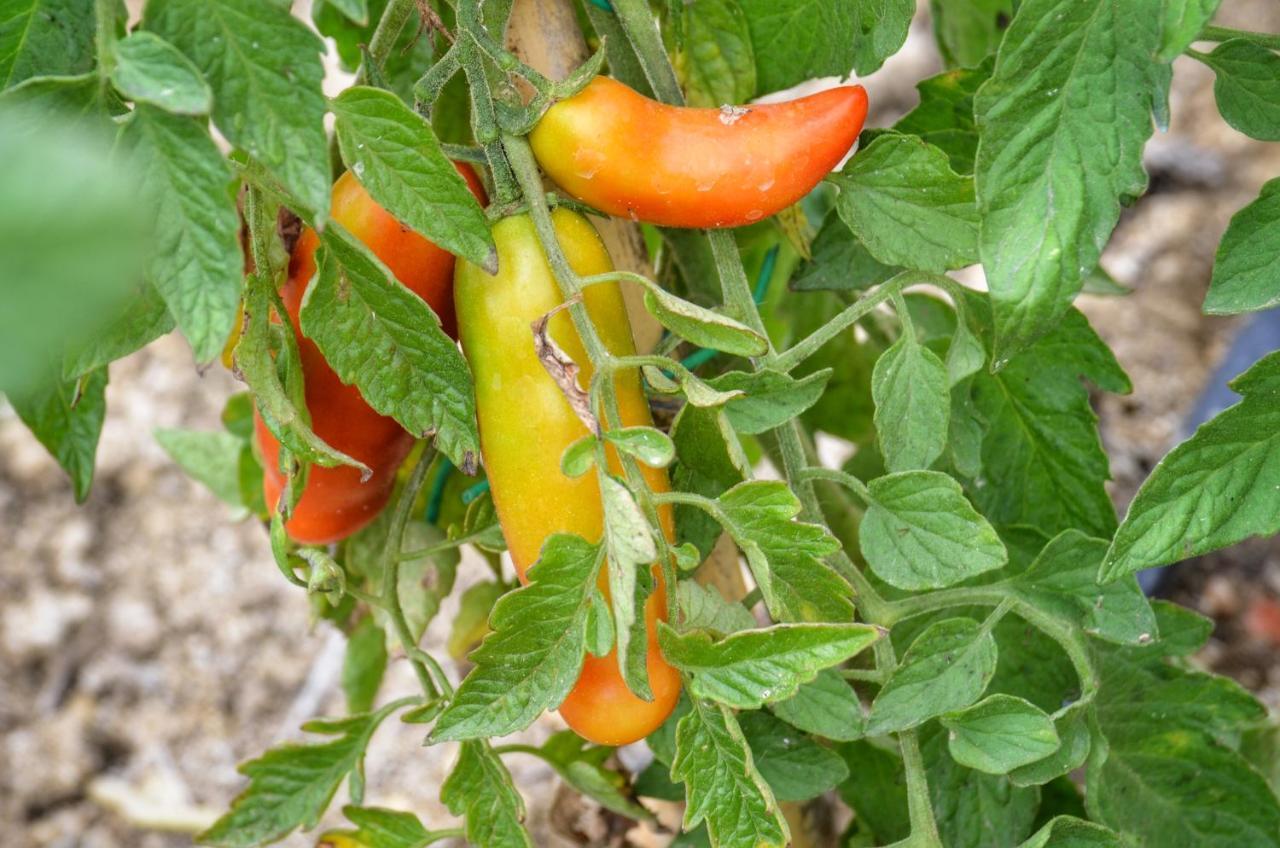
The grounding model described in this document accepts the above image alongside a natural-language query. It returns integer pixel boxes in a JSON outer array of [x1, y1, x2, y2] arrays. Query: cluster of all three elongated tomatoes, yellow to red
[[257, 77, 867, 746]]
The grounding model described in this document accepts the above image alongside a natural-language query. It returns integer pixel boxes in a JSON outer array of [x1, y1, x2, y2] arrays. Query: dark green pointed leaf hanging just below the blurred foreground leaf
[[8, 368, 106, 503]]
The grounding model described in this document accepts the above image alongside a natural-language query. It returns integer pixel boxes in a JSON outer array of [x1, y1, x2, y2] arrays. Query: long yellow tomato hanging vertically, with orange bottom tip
[[453, 208, 680, 744]]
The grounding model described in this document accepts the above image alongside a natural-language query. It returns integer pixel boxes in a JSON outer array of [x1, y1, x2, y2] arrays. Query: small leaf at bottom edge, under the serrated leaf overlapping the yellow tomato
[[440, 742, 534, 848]]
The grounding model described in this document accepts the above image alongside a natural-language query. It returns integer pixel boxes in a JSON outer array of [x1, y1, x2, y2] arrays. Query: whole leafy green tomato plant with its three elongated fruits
[[0, 0, 1280, 848]]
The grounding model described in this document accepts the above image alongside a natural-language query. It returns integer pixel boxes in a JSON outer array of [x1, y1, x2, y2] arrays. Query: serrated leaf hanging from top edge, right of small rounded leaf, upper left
[[142, 0, 330, 217]]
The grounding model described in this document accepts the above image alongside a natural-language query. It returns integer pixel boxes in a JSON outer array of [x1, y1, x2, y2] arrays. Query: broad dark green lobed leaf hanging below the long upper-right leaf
[[968, 298, 1129, 537]]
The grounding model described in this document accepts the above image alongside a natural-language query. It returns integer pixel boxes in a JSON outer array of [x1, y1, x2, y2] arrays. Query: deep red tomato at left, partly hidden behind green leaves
[[253, 164, 484, 544]]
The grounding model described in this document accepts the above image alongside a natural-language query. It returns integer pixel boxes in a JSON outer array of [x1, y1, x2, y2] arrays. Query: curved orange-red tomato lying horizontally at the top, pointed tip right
[[529, 77, 867, 227]]
